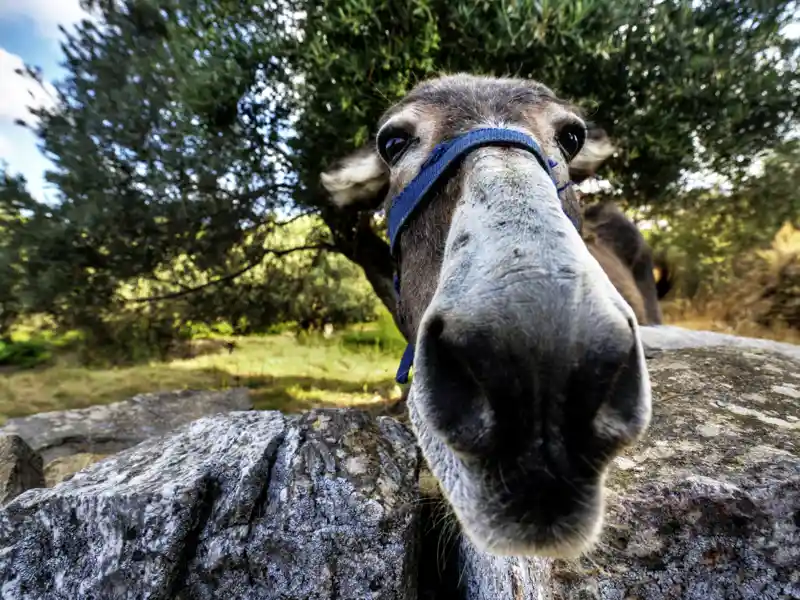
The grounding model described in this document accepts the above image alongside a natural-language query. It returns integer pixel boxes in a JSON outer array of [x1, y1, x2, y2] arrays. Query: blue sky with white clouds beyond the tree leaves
[[0, 0, 800, 201]]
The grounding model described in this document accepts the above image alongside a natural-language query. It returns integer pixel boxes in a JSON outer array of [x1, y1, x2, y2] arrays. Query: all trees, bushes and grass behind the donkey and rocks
[[0, 0, 800, 414]]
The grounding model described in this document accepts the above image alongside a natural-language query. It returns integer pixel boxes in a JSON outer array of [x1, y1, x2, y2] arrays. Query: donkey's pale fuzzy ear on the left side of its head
[[320, 144, 389, 209]]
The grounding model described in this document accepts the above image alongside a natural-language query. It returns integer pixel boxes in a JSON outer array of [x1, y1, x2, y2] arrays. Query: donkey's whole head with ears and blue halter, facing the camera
[[322, 75, 650, 556]]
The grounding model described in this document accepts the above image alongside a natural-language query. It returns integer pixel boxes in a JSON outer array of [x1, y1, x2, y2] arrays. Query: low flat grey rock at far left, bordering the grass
[[0, 388, 253, 464]]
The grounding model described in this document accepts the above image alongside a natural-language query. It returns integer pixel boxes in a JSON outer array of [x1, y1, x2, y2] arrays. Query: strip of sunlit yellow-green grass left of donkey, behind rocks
[[0, 334, 400, 419]]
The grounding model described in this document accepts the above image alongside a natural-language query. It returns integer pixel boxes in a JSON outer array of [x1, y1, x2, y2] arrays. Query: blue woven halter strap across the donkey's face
[[388, 128, 578, 383]]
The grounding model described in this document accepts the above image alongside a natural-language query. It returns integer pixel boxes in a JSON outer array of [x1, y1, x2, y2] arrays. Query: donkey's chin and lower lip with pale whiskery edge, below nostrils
[[408, 386, 605, 558]]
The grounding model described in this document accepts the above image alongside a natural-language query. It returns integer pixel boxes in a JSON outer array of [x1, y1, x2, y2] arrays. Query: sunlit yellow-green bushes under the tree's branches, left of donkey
[[64, 218, 376, 364]]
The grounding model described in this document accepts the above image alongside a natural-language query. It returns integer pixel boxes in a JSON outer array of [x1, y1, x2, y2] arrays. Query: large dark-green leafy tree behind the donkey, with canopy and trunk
[[10, 0, 800, 338]]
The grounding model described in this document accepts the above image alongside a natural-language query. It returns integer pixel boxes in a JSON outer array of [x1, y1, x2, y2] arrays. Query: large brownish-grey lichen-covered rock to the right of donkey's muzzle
[[554, 345, 800, 600]]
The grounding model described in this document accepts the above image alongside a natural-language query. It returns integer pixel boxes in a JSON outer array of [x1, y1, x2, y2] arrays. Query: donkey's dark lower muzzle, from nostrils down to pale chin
[[408, 315, 640, 557]]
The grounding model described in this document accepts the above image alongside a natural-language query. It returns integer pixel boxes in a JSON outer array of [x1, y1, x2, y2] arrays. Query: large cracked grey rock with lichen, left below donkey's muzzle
[[0, 410, 418, 600]]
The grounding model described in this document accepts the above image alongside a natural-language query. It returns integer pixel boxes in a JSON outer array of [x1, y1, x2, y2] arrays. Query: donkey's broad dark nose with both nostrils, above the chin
[[415, 276, 643, 470]]
